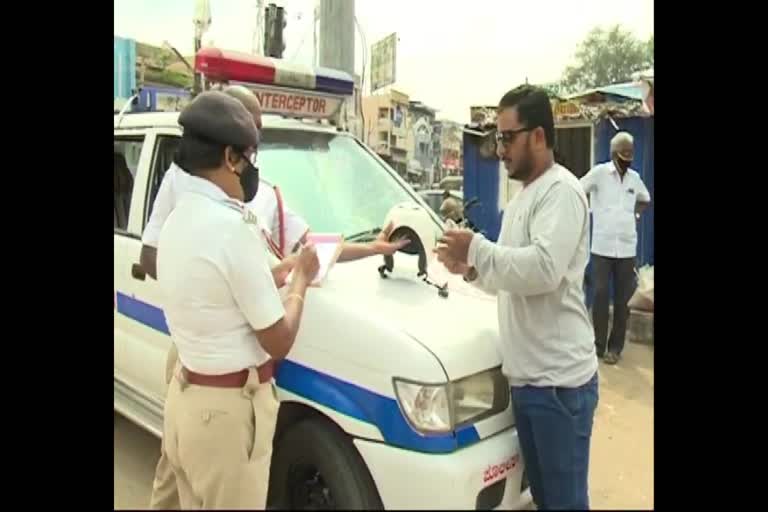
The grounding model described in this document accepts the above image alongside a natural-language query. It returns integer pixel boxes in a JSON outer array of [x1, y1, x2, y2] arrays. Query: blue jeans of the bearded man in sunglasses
[[512, 374, 598, 510]]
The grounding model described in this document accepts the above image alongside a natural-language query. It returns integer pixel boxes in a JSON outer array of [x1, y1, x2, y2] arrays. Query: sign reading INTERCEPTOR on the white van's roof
[[232, 82, 344, 119]]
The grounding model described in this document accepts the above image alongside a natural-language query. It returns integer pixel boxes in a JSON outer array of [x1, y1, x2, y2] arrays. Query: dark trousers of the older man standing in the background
[[592, 254, 635, 356]]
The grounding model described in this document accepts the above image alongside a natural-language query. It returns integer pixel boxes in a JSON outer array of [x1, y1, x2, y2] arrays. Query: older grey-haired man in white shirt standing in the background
[[581, 132, 651, 364]]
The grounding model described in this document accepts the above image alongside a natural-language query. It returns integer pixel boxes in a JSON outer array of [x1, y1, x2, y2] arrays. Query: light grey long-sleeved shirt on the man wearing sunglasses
[[468, 164, 597, 387]]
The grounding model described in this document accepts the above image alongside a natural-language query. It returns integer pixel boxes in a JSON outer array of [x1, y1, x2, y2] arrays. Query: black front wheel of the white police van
[[268, 418, 384, 510]]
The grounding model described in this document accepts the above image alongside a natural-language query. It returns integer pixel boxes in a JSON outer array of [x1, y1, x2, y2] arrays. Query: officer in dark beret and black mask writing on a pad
[[150, 91, 319, 509]]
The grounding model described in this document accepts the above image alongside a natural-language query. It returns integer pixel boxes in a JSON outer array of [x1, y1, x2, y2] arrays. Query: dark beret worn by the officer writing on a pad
[[179, 91, 259, 148]]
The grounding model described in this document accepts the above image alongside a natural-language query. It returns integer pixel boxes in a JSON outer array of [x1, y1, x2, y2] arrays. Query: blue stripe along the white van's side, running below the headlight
[[117, 292, 480, 453]]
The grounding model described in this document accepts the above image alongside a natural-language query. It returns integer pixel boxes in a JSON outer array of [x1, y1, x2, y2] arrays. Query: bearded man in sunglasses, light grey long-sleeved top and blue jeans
[[436, 85, 598, 510]]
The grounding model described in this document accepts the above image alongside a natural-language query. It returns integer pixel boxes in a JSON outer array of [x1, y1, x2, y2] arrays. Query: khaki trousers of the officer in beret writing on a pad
[[151, 346, 278, 509]]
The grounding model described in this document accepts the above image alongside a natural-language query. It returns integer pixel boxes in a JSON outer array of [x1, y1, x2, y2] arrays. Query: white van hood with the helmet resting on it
[[323, 253, 501, 380]]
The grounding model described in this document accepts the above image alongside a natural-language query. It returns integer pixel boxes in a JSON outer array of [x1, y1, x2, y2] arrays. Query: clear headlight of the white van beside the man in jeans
[[394, 368, 509, 434]]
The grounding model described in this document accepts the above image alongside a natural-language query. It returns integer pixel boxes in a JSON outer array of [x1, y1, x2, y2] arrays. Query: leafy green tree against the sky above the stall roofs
[[562, 25, 653, 92]]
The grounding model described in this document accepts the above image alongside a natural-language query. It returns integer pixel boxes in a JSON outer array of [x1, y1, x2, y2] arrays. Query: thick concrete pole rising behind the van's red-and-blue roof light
[[320, 0, 355, 75]]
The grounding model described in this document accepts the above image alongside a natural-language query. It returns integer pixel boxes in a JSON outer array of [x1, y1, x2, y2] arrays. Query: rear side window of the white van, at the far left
[[113, 136, 144, 233]]
